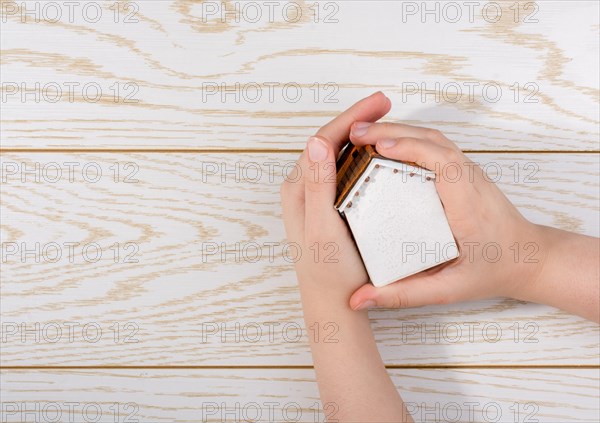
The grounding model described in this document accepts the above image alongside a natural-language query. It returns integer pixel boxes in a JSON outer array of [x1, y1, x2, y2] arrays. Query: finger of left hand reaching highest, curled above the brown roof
[[317, 91, 392, 157]]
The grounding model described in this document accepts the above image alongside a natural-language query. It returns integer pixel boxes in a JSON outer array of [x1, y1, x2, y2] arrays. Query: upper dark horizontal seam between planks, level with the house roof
[[0, 148, 600, 154]]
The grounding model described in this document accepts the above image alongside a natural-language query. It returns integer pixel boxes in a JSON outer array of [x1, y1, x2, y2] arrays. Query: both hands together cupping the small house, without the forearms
[[281, 92, 546, 310]]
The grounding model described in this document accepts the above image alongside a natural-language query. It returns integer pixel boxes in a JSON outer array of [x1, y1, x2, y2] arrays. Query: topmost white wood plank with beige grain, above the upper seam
[[1, 1, 600, 150]]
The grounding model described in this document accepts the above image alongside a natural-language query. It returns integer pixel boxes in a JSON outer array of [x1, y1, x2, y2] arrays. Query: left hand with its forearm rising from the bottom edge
[[281, 93, 412, 422]]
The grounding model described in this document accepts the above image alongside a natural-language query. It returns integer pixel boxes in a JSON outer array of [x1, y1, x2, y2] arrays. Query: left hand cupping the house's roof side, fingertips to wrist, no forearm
[[281, 93, 390, 307]]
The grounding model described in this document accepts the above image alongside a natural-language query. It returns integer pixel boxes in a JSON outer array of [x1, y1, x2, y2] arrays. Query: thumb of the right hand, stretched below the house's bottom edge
[[350, 275, 450, 310]]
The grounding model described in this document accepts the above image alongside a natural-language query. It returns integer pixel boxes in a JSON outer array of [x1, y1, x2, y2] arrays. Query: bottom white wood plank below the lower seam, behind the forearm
[[0, 369, 600, 422]]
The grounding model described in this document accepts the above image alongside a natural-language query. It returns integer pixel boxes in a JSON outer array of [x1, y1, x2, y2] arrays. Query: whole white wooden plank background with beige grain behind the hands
[[0, 0, 600, 422]]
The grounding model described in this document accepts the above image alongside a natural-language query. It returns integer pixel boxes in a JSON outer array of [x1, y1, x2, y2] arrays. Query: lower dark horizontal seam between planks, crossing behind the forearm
[[0, 364, 600, 371]]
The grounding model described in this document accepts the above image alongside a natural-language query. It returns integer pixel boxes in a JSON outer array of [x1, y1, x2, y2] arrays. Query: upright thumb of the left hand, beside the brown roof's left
[[304, 137, 340, 241]]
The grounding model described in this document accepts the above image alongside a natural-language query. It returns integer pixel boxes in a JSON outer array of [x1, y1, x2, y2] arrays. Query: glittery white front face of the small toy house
[[340, 159, 458, 286]]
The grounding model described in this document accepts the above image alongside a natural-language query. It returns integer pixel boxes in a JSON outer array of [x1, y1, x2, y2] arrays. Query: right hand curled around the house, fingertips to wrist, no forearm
[[350, 122, 547, 309]]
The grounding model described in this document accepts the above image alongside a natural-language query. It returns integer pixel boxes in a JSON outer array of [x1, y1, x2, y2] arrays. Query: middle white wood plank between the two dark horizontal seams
[[0, 153, 599, 366]]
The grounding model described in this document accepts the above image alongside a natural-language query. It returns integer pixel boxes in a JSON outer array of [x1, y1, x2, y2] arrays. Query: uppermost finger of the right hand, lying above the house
[[350, 122, 453, 145]]
